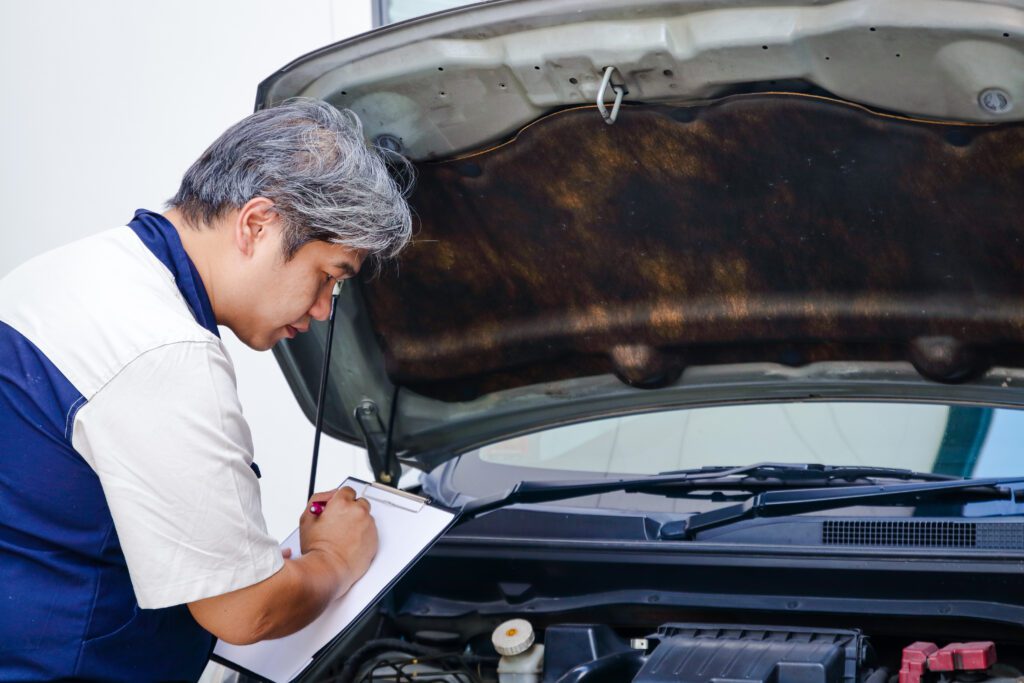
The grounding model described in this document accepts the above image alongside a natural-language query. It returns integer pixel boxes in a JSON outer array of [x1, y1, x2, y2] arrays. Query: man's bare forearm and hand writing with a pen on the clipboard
[[188, 487, 377, 645]]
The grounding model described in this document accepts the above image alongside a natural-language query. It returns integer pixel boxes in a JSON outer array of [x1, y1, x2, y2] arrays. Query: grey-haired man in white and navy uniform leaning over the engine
[[0, 100, 411, 681]]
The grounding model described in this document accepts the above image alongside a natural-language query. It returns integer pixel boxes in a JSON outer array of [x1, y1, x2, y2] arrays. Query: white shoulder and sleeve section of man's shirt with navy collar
[[0, 212, 284, 608]]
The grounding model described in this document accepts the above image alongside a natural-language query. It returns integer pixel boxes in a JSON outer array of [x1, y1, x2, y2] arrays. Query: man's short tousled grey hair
[[168, 98, 413, 264]]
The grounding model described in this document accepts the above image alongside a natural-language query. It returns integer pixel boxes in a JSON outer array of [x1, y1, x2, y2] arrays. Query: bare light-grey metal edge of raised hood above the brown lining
[[257, 0, 1024, 161]]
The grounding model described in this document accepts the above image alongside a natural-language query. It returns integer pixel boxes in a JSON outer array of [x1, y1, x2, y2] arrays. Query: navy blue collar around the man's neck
[[128, 209, 220, 337]]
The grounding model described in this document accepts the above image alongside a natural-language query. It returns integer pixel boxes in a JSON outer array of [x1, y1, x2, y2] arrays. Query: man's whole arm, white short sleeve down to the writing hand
[[73, 338, 377, 642]]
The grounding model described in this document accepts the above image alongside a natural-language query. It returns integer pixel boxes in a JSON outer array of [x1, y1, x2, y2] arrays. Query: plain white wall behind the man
[[0, 0, 371, 538]]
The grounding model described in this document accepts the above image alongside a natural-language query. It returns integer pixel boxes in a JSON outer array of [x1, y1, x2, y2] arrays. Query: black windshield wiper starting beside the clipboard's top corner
[[462, 463, 961, 519]]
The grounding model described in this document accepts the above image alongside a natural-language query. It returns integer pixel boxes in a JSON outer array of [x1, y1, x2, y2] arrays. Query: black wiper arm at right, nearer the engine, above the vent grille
[[659, 477, 1024, 540]]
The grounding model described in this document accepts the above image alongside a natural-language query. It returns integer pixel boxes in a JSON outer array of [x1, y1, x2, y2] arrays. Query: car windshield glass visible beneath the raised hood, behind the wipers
[[431, 401, 1024, 511]]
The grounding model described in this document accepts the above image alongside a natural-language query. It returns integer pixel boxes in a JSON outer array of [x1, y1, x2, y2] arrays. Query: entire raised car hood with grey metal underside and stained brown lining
[[257, 0, 1024, 480]]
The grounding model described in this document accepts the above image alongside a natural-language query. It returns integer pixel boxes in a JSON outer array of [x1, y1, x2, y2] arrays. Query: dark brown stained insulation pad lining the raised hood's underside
[[362, 94, 1024, 400]]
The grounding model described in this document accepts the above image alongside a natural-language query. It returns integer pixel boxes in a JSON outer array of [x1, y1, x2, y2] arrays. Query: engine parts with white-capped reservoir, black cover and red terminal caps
[[337, 618, 1022, 683]]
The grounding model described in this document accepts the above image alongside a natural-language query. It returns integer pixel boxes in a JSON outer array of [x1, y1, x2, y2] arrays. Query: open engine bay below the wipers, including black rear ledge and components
[[286, 518, 1024, 683]]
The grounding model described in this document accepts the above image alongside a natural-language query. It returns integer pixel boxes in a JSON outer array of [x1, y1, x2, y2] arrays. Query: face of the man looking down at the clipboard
[[231, 225, 365, 350]]
